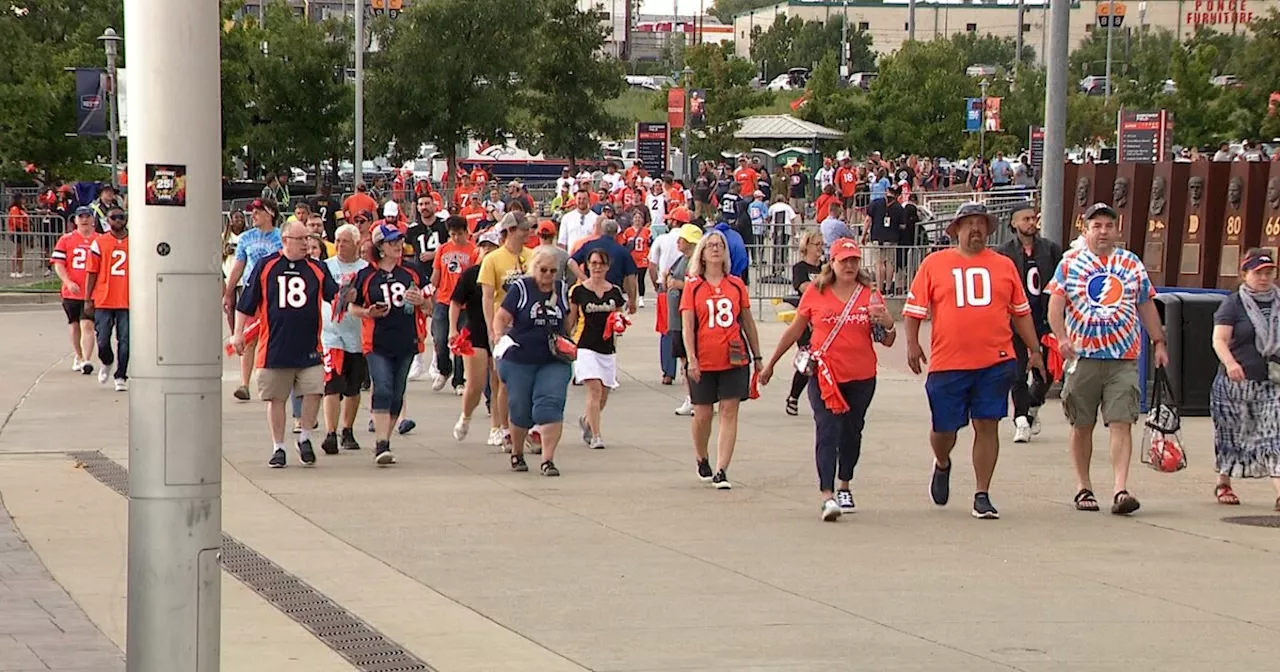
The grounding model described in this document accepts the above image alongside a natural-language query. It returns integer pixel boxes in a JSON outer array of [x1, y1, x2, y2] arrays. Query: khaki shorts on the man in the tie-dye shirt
[[1062, 360, 1142, 428]]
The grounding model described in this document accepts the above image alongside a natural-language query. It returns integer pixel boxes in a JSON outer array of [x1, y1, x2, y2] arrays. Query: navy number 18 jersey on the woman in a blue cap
[[356, 266, 422, 357]]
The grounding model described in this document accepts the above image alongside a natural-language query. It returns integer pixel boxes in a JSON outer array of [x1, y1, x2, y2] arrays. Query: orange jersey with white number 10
[[902, 248, 1032, 372]]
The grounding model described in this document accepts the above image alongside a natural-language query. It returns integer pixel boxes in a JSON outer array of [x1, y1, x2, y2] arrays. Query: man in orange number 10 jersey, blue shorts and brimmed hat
[[902, 204, 1044, 518]]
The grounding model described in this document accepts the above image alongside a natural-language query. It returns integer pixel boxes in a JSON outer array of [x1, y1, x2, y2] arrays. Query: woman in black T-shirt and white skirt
[[568, 248, 626, 449]]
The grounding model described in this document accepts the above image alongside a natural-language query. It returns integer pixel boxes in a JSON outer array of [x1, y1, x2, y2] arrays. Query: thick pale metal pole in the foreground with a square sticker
[[124, 0, 223, 672]]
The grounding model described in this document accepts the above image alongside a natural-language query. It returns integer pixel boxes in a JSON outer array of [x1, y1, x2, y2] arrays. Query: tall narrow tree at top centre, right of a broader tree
[[521, 0, 626, 169]]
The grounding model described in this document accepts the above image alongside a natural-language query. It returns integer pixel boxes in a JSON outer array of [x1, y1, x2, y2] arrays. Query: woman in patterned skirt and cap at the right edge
[[1210, 248, 1280, 511]]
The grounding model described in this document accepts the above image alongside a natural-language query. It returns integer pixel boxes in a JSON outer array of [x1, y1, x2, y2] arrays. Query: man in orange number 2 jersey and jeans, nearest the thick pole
[[84, 206, 129, 392]]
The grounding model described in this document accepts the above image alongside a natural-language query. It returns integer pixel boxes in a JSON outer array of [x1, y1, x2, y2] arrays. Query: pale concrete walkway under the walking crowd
[[0, 308, 1280, 672]]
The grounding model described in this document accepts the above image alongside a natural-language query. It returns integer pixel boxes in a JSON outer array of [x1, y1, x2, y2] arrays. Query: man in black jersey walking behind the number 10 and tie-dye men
[[996, 202, 1062, 443]]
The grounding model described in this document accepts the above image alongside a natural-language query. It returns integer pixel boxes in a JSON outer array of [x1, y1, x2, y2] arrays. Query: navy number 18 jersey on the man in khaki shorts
[[236, 252, 338, 369]]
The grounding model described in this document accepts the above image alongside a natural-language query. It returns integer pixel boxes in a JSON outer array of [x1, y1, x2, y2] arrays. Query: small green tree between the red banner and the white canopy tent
[[686, 44, 773, 156]]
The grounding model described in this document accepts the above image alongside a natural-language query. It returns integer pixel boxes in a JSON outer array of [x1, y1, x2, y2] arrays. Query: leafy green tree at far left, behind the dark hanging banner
[[0, 0, 125, 182]]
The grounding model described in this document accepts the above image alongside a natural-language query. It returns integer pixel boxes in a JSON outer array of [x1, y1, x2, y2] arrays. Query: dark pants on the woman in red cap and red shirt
[[809, 378, 876, 492]]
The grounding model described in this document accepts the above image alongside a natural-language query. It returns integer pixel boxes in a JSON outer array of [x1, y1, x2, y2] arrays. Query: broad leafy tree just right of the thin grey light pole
[[365, 0, 540, 179]]
